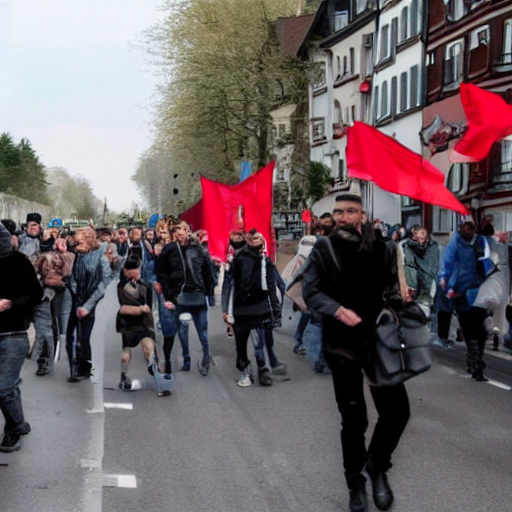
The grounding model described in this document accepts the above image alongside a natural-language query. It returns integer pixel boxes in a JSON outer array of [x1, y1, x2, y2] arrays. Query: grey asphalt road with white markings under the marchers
[[0, 284, 512, 512]]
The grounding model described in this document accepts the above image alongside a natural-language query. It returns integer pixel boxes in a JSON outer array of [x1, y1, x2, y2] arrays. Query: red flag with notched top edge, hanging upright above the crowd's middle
[[201, 162, 275, 260]]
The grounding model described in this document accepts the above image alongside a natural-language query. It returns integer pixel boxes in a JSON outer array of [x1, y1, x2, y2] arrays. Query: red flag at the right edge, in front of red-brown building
[[449, 84, 512, 162]]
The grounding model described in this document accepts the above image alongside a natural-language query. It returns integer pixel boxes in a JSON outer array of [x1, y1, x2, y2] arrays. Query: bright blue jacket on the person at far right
[[439, 233, 487, 293]]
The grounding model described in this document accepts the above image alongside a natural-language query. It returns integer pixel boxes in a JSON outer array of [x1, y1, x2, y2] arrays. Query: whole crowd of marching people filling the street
[[0, 203, 510, 512]]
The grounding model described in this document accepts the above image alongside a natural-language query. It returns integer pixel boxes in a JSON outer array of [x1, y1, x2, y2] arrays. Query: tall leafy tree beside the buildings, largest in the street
[[142, 0, 314, 191]]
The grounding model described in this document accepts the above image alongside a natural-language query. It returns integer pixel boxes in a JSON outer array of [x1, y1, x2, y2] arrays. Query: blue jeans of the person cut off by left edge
[[0, 332, 29, 432]]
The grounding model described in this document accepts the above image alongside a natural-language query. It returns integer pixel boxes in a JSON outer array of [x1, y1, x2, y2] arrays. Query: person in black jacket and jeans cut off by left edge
[[0, 223, 43, 452]]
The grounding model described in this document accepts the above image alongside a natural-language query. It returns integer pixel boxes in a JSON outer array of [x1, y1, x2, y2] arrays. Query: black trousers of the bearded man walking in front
[[325, 353, 410, 488]]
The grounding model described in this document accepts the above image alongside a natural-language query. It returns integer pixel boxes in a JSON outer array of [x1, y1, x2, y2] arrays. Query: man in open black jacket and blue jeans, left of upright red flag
[[155, 221, 213, 376]]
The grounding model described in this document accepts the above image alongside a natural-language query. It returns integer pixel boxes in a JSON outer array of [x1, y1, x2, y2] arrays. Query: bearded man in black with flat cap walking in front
[[303, 194, 409, 512]]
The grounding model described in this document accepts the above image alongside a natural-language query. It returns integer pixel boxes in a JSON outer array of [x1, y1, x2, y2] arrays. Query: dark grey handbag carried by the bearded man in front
[[367, 303, 432, 386]]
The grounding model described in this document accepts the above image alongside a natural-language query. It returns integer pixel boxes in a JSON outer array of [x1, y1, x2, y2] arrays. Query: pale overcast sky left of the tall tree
[[0, 0, 164, 212]]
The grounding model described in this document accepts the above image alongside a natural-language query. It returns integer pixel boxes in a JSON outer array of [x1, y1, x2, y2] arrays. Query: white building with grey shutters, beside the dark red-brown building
[[368, 0, 426, 227]]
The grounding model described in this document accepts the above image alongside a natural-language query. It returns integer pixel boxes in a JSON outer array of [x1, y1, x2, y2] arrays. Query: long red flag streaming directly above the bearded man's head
[[347, 121, 469, 214]]
